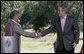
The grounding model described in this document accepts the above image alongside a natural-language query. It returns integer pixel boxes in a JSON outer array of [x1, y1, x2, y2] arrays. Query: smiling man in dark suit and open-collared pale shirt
[[39, 5, 80, 53]]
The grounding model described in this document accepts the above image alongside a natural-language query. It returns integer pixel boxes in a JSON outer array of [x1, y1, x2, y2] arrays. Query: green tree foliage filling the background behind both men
[[1, 1, 83, 31]]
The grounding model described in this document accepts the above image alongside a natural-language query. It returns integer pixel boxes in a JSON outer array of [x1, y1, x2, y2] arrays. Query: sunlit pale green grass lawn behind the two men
[[20, 29, 83, 53]]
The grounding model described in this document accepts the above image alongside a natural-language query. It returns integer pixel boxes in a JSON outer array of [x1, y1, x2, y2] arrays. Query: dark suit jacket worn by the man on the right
[[41, 16, 80, 50]]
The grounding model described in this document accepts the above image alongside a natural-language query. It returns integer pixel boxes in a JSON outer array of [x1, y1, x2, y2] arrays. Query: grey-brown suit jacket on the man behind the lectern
[[4, 20, 35, 38]]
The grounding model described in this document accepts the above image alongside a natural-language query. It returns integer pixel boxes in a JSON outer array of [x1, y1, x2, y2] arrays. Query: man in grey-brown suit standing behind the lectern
[[4, 10, 40, 50]]
